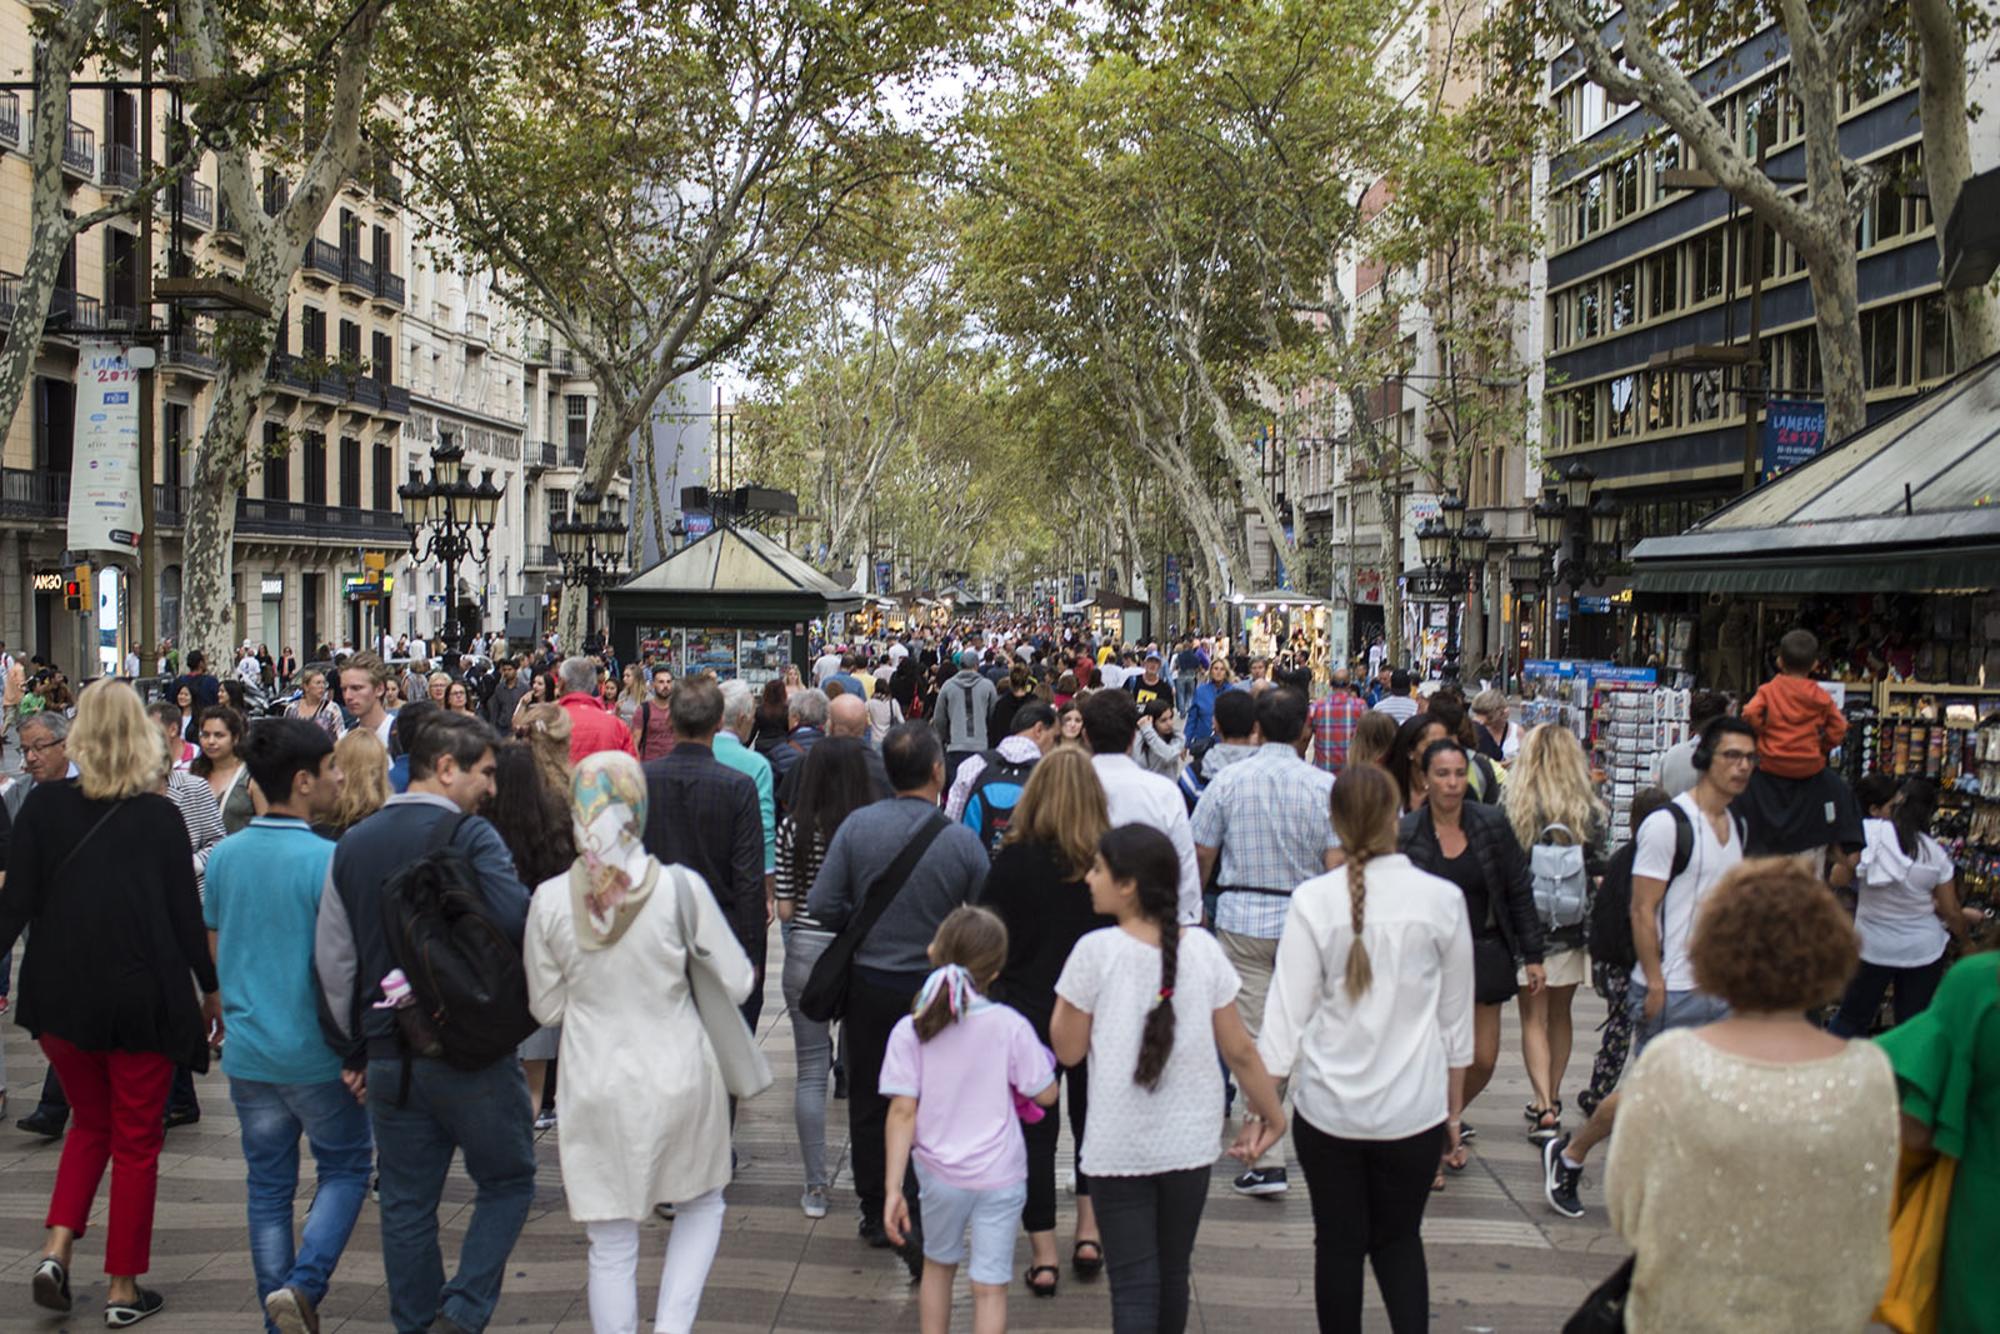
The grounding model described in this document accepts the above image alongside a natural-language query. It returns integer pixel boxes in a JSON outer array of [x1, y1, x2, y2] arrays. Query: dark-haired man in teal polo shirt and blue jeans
[[202, 718, 374, 1334]]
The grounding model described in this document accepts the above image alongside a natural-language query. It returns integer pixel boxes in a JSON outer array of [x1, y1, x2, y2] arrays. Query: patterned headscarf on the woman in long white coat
[[570, 750, 658, 950]]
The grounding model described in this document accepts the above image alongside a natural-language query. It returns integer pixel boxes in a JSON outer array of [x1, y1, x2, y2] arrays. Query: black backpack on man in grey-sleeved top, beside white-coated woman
[[382, 814, 536, 1086]]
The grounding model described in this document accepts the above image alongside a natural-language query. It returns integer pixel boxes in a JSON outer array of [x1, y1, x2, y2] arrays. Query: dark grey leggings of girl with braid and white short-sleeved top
[[1090, 1168, 1210, 1334]]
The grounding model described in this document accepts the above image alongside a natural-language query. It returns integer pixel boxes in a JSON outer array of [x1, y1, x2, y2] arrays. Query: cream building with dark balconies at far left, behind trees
[[0, 0, 410, 674]]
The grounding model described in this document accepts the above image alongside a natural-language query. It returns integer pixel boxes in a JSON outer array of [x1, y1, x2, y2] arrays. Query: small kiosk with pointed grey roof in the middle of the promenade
[[604, 526, 866, 686]]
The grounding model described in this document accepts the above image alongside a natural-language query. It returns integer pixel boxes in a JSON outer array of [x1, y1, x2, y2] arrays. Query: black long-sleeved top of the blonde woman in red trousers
[[0, 782, 216, 1070]]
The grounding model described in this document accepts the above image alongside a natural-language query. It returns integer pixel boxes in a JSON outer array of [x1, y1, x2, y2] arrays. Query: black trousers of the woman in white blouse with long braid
[[1292, 1116, 1444, 1334]]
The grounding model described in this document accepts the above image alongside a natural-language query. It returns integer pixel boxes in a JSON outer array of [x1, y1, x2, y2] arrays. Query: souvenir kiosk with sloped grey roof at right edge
[[1632, 358, 2000, 928]]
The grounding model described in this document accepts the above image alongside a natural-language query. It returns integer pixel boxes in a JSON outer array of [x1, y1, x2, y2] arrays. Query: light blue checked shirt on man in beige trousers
[[1194, 742, 1340, 940]]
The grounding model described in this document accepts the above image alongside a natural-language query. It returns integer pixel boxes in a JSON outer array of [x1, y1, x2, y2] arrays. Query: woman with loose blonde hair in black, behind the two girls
[[980, 746, 1112, 1296]]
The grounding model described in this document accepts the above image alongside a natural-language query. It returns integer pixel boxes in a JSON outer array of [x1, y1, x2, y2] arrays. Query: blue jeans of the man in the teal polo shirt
[[230, 1078, 374, 1330]]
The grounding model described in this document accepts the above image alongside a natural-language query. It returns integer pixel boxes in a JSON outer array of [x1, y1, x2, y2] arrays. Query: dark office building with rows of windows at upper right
[[1544, 26, 2000, 580]]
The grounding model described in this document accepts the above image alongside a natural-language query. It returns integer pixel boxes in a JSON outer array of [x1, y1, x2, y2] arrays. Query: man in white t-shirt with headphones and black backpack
[[1542, 718, 1756, 1218]]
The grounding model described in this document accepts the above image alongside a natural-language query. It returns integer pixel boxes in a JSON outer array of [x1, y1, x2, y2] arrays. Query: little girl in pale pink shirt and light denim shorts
[[880, 908, 1056, 1334]]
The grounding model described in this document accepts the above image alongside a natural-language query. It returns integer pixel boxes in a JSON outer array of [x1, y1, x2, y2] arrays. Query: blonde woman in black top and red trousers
[[0, 680, 222, 1328]]
